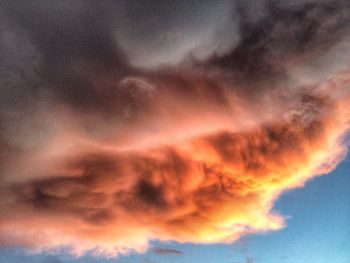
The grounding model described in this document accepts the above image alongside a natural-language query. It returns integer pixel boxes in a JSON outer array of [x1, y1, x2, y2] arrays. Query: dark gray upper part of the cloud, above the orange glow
[[1, 0, 350, 118]]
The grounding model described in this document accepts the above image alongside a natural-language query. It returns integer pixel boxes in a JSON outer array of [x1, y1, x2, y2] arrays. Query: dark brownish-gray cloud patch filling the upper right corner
[[207, 0, 350, 89]]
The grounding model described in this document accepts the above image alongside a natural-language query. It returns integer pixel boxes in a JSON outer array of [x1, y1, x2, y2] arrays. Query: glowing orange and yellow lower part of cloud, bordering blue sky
[[0, 68, 350, 255]]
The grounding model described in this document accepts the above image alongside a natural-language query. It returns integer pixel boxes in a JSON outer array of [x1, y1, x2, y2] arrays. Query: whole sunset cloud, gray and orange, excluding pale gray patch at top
[[0, 1, 350, 255]]
